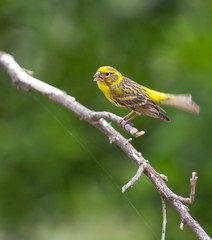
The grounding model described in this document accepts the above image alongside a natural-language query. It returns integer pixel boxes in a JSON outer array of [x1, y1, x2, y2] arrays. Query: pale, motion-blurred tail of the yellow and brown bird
[[160, 94, 200, 114]]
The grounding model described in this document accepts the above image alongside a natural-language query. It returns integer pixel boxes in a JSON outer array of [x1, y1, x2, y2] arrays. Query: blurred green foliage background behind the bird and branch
[[0, 0, 212, 240]]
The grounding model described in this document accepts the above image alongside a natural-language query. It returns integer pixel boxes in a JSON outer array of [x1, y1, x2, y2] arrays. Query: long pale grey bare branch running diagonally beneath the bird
[[0, 52, 211, 240]]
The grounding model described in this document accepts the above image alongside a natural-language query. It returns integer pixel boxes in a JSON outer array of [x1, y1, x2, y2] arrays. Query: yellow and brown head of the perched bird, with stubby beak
[[94, 66, 122, 87]]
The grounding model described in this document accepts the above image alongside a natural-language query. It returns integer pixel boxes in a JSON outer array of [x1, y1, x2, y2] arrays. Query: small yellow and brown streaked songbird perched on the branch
[[94, 66, 199, 122]]
